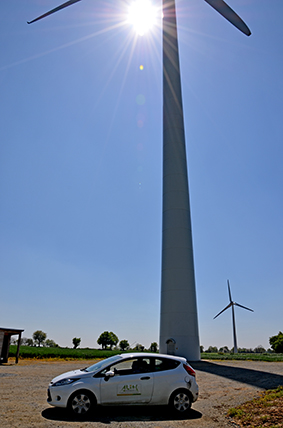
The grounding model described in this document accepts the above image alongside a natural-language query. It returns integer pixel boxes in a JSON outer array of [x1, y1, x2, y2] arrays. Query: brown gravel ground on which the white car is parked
[[0, 360, 283, 428]]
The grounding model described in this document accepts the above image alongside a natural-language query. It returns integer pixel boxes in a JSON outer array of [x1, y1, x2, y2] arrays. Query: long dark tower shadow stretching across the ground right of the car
[[193, 361, 283, 389]]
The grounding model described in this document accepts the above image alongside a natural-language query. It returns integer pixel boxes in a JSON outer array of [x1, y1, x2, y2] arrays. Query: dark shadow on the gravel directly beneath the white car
[[41, 406, 202, 425]]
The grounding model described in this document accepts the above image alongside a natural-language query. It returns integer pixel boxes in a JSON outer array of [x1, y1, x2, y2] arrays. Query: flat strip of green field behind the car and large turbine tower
[[9, 345, 283, 361]]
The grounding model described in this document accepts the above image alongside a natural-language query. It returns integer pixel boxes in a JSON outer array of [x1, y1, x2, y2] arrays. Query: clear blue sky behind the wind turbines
[[0, 0, 283, 348]]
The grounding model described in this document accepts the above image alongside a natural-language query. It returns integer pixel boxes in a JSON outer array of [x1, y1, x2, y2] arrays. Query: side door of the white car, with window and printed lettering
[[100, 358, 154, 405]]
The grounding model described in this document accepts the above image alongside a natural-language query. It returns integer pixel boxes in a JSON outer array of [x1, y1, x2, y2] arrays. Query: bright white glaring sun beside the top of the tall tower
[[128, 0, 157, 36]]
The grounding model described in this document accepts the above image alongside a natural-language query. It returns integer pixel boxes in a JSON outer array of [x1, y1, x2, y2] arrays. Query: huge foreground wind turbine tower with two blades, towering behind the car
[[28, 0, 251, 361]]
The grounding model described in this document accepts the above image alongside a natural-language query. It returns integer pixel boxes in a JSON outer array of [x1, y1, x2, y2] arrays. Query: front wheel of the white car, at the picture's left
[[68, 389, 96, 418]]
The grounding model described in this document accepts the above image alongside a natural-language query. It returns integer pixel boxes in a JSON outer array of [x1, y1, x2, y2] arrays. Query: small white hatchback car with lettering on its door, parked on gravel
[[47, 352, 198, 416]]
